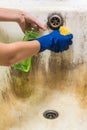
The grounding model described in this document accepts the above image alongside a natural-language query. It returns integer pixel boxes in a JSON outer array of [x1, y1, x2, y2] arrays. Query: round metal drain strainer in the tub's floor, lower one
[[43, 110, 59, 119]]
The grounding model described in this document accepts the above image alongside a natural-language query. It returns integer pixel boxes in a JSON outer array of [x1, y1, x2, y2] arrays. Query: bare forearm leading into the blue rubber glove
[[0, 40, 40, 66]]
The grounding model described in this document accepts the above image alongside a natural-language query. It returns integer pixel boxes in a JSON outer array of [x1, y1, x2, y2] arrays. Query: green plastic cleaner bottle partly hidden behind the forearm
[[13, 30, 38, 72]]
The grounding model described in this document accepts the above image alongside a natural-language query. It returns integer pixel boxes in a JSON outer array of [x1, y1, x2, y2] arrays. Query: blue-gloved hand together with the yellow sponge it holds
[[36, 27, 73, 53]]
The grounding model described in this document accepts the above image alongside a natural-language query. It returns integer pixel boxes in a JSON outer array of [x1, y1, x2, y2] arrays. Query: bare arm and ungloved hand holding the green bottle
[[0, 8, 45, 32]]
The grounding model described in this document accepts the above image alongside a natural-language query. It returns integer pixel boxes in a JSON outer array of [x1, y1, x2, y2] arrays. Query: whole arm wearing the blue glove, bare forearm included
[[0, 26, 73, 66]]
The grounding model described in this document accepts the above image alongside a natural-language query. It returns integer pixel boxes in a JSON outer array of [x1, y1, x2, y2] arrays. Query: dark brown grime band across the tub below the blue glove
[[11, 51, 87, 108]]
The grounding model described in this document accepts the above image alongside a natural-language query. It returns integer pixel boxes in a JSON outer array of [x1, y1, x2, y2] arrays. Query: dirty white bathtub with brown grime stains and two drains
[[0, 0, 87, 130]]
